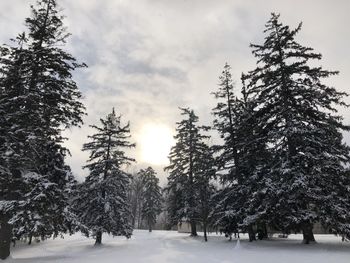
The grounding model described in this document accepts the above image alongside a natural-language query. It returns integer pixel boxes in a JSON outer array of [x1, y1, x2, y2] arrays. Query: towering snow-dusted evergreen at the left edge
[[0, 0, 85, 257]]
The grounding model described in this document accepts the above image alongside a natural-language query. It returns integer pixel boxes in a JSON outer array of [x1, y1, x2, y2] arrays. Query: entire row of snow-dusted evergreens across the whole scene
[[0, 0, 350, 259]]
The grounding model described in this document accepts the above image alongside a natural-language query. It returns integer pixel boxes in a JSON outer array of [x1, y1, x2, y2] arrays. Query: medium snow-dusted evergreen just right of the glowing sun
[[165, 109, 213, 236]]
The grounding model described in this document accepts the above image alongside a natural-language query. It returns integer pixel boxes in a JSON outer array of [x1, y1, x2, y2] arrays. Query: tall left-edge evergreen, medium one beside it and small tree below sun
[[0, 0, 161, 259]]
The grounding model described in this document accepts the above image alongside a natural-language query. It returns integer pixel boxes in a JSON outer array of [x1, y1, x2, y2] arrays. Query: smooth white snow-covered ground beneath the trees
[[5, 230, 350, 263]]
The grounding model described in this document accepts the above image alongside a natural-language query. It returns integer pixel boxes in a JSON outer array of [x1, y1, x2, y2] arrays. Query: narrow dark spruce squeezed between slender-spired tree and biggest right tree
[[236, 75, 273, 241]]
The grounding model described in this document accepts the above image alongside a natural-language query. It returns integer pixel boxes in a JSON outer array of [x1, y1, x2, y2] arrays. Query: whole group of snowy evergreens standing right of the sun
[[166, 14, 350, 243]]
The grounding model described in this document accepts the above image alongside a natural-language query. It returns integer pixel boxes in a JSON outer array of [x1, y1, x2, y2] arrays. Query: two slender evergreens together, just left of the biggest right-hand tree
[[212, 63, 268, 241]]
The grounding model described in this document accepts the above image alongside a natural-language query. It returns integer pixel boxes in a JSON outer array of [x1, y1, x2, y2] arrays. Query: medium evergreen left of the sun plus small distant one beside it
[[70, 108, 162, 248]]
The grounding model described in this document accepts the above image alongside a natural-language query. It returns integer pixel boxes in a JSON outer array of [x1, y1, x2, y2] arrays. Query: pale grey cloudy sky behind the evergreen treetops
[[0, 0, 350, 185]]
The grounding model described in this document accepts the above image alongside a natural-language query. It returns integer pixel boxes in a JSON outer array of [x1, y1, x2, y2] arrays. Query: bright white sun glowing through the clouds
[[138, 123, 175, 165]]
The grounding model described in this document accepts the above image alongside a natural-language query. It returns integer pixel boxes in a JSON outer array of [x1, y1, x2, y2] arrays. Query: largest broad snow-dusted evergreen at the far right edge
[[246, 14, 350, 243]]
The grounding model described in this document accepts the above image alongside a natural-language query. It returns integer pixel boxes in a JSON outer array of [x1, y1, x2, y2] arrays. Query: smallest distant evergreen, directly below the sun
[[139, 167, 162, 232]]
